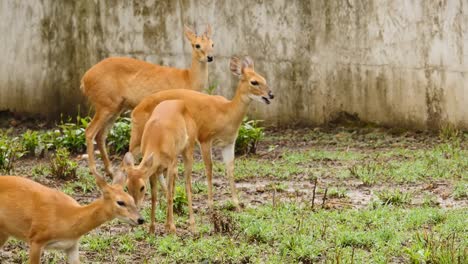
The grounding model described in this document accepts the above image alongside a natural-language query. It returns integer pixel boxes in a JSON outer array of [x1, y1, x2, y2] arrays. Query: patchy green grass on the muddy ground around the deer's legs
[[0, 125, 468, 263]]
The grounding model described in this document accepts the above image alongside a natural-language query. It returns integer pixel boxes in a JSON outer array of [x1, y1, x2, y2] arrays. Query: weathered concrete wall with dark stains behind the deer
[[0, 0, 468, 129]]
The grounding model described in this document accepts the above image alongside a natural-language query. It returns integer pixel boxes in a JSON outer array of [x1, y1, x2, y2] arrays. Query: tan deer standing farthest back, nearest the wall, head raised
[[81, 25, 214, 175]]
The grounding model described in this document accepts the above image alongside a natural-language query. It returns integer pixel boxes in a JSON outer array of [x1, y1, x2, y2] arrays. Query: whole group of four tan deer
[[0, 25, 273, 263]]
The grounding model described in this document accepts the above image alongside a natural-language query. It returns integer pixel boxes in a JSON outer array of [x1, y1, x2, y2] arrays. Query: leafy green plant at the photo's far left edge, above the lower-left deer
[[0, 131, 25, 173]]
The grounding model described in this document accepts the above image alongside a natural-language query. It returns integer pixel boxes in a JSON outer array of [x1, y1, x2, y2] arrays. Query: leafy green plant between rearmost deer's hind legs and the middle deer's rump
[[108, 117, 132, 154]]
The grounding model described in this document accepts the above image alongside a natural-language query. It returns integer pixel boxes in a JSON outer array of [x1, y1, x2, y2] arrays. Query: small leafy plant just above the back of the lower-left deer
[[50, 148, 78, 180]]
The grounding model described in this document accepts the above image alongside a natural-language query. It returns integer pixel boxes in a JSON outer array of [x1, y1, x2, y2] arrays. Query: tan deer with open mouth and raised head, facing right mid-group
[[130, 57, 273, 209]]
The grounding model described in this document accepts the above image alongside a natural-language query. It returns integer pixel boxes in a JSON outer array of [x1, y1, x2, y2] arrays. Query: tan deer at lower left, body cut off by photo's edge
[[0, 170, 144, 264]]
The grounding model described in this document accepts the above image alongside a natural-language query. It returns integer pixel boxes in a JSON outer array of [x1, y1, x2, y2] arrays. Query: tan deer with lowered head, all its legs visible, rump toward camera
[[123, 100, 196, 233]]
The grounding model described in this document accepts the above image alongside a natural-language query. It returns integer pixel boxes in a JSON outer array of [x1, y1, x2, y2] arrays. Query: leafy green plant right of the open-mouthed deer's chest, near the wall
[[235, 117, 264, 154]]
